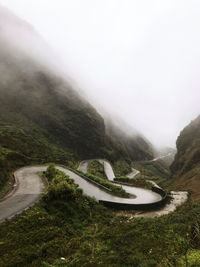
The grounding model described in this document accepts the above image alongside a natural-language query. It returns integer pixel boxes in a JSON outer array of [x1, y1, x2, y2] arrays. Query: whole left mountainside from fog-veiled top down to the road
[[0, 6, 154, 191]]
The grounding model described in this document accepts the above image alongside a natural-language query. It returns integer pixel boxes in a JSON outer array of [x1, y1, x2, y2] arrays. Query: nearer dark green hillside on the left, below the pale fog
[[0, 47, 105, 191]]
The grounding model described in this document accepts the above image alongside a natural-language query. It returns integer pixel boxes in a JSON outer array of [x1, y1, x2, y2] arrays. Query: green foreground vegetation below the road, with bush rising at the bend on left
[[0, 165, 200, 267]]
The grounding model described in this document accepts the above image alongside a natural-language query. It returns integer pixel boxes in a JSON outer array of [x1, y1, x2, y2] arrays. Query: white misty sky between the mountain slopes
[[0, 0, 200, 149]]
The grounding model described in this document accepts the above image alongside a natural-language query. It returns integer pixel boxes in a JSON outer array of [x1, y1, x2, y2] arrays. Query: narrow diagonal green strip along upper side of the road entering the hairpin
[[76, 171, 130, 198]]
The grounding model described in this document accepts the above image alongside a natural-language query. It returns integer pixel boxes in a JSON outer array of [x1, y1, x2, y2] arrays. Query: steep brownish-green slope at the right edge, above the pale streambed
[[171, 116, 200, 199]]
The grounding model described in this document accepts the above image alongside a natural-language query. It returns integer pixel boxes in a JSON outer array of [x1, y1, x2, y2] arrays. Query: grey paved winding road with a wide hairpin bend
[[0, 163, 161, 222]]
